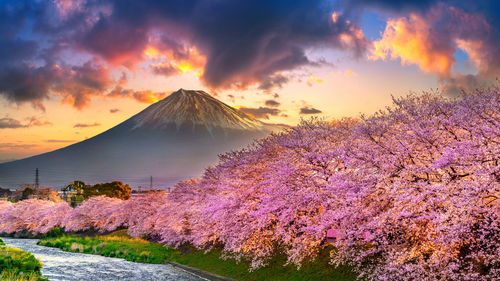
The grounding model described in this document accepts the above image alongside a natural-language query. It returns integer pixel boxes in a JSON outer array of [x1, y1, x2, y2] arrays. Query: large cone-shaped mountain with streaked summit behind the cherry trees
[[0, 89, 279, 188]]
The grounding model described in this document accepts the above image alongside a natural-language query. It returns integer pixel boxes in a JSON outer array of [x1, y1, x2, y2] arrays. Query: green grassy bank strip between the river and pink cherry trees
[[39, 231, 356, 281]]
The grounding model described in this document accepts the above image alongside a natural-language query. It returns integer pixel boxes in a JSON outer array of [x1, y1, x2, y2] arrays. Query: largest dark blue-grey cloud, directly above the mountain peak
[[66, 0, 367, 88]]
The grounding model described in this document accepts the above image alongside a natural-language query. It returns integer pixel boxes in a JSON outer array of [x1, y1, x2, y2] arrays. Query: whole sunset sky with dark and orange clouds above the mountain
[[0, 0, 500, 162]]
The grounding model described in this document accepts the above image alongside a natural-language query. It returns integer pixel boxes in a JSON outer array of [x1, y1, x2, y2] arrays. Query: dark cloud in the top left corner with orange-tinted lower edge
[[0, 1, 111, 110]]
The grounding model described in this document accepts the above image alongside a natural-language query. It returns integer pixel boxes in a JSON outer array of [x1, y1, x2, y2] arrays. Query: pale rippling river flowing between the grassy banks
[[2, 238, 206, 281]]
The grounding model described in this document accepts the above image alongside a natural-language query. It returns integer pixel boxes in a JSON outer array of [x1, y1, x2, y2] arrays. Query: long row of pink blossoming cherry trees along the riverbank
[[0, 88, 500, 280]]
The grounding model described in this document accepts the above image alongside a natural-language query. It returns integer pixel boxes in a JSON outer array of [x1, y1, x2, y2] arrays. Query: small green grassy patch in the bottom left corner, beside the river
[[0, 239, 48, 281]]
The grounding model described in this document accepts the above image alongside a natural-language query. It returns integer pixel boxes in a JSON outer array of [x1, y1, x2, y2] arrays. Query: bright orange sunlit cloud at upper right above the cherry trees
[[369, 4, 491, 83]]
